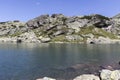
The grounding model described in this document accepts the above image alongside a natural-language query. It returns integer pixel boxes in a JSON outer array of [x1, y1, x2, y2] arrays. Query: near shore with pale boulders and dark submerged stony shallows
[[36, 63, 120, 80]]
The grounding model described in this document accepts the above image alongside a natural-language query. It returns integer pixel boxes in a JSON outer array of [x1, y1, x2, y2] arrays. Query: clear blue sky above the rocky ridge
[[0, 0, 120, 21]]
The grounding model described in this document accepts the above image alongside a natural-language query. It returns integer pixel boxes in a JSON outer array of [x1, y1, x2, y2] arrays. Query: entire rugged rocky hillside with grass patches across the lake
[[0, 14, 120, 44]]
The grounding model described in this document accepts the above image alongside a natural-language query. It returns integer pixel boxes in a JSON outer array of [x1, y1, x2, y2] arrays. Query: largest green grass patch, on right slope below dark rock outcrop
[[76, 26, 118, 42]]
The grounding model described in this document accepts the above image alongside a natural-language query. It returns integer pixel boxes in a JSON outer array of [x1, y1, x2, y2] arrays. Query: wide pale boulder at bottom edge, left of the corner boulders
[[73, 74, 100, 80]]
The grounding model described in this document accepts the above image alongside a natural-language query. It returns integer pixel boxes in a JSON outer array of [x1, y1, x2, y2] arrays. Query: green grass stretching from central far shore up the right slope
[[52, 26, 117, 43]]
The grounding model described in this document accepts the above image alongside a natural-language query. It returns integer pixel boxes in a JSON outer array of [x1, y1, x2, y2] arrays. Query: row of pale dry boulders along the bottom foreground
[[36, 69, 120, 80]]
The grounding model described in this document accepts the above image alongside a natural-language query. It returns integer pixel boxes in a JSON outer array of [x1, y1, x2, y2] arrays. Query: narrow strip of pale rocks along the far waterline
[[0, 37, 120, 44]]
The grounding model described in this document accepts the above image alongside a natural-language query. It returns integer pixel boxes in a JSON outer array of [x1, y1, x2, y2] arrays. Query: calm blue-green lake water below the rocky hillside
[[0, 43, 120, 80]]
